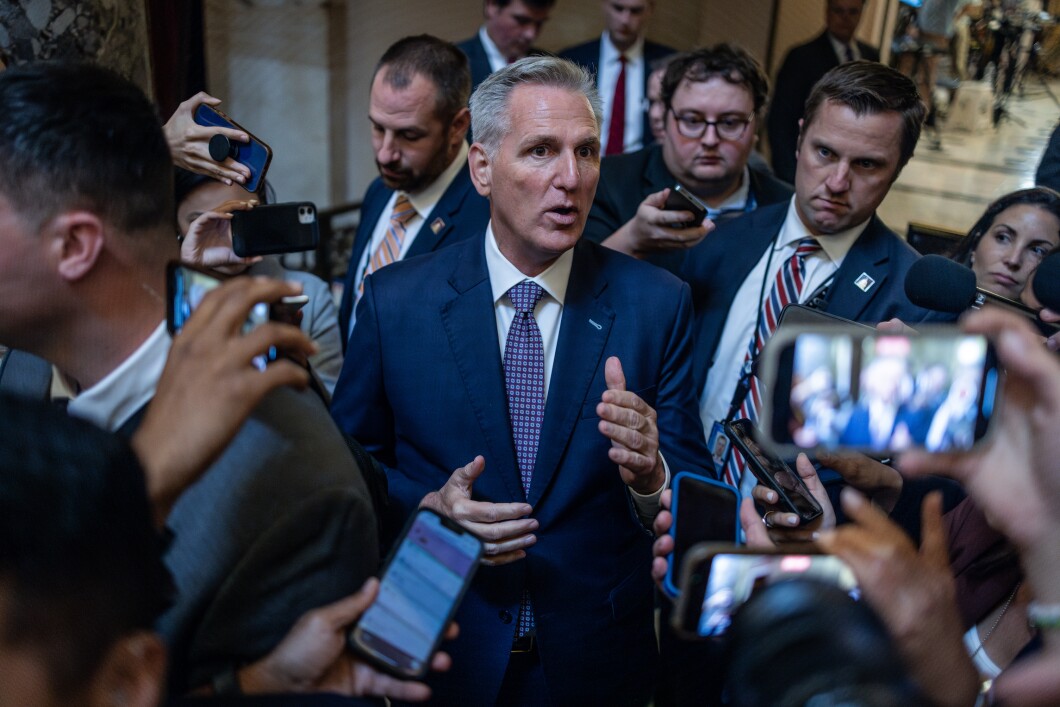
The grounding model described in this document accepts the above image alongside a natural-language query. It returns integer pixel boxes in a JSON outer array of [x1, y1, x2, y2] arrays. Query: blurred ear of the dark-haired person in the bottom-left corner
[[91, 631, 165, 707]]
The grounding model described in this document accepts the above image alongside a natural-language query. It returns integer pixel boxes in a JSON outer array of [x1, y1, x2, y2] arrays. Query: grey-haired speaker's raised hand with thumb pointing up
[[597, 356, 666, 495]]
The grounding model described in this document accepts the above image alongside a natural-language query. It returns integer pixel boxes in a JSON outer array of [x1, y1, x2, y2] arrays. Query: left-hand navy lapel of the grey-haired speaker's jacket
[[441, 238, 524, 501]]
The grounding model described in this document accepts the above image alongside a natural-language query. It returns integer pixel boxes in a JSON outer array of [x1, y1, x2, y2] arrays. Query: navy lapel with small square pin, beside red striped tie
[[827, 216, 890, 321]]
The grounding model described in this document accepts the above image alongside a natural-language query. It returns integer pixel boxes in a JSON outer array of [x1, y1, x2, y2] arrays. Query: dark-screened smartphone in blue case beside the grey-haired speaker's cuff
[[663, 472, 740, 597]]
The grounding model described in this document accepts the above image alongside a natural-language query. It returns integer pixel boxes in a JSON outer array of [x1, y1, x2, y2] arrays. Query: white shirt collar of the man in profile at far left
[[67, 321, 173, 431]]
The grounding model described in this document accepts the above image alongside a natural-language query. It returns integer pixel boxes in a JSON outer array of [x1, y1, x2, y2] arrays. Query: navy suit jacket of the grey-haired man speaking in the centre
[[332, 237, 709, 705]]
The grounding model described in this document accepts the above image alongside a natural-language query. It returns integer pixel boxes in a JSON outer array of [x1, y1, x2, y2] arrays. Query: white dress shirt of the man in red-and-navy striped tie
[[700, 197, 868, 435]]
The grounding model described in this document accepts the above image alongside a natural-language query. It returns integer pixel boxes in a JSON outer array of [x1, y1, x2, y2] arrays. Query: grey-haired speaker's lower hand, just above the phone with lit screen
[[420, 456, 537, 565]]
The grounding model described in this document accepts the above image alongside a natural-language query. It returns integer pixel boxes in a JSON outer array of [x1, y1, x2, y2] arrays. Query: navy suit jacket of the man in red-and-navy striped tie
[[682, 202, 954, 391]]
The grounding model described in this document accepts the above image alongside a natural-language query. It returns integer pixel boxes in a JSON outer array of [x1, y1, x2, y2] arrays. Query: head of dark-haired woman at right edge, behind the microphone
[[951, 187, 1060, 300]]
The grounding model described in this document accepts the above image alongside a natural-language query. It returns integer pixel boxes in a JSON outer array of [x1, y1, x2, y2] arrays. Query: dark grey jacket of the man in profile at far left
[[0, 352, 379, 693]]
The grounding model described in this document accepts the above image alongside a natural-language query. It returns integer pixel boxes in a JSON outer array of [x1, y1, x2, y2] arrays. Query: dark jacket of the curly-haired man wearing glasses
[[585, 145, 792, 275]]
